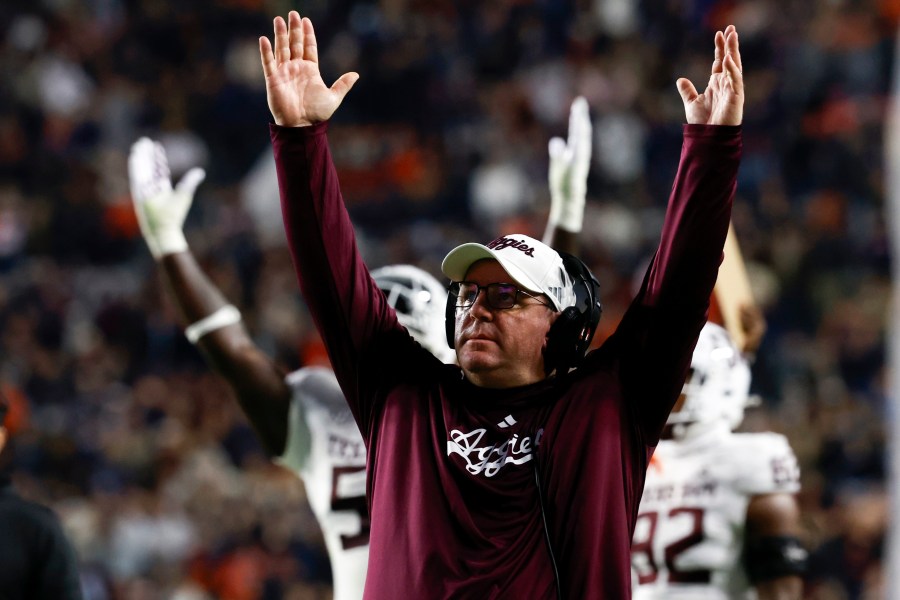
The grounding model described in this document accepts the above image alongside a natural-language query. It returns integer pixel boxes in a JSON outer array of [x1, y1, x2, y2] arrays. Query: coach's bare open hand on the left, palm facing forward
[[259, 10, 359, 127]]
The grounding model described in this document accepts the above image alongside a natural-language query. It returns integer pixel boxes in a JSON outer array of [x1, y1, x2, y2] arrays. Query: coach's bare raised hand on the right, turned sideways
[[676, 25, 744, 125]]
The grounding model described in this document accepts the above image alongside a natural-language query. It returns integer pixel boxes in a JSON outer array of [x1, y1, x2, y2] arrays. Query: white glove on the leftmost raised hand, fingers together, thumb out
[[128, 137, 206, 260]]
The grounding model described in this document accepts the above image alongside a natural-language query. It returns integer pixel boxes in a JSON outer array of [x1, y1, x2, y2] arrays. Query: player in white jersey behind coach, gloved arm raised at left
[[128, 138, 452, 600]]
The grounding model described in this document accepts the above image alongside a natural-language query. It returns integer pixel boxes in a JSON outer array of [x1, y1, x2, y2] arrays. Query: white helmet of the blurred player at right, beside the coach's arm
[[667, 322, 751, 438]]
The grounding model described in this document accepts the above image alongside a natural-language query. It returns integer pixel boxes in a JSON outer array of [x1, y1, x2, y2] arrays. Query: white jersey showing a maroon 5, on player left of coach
[[275, 367, 369, 600]]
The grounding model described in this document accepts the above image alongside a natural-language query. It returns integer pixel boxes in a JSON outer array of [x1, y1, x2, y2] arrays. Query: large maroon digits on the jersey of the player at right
[[631, 507, 712, 585]]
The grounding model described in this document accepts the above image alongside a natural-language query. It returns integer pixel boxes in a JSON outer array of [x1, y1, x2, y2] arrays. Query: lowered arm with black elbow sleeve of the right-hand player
[[744, 493, 807, 600]]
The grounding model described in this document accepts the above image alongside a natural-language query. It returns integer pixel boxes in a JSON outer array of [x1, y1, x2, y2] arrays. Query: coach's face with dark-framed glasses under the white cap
[[454, 259, 559, 388]]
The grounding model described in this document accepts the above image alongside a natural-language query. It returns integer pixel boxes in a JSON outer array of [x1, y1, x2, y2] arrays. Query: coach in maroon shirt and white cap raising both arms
[[260, 12, 744, 599]]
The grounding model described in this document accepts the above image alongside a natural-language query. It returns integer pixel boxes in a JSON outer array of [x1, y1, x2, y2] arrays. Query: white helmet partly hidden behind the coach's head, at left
[[372, 265, 456, 363]]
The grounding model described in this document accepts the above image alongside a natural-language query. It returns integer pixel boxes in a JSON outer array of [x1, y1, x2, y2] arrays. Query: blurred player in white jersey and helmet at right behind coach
[[631, 323, 806, 600]]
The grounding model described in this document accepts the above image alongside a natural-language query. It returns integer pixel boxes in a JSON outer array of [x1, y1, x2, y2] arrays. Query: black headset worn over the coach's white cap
[[444, 252, 603, 375]]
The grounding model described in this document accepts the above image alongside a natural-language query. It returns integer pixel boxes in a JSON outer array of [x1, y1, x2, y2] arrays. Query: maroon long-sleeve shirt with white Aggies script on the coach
[[271, 123, 741, 600]]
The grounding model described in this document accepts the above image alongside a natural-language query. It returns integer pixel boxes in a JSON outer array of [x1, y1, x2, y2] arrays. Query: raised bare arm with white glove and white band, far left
[[128, 138, 290, 456]]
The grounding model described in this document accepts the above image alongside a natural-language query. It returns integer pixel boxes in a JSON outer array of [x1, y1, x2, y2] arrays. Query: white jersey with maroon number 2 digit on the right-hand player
[[631, 426, 800, 600]]
